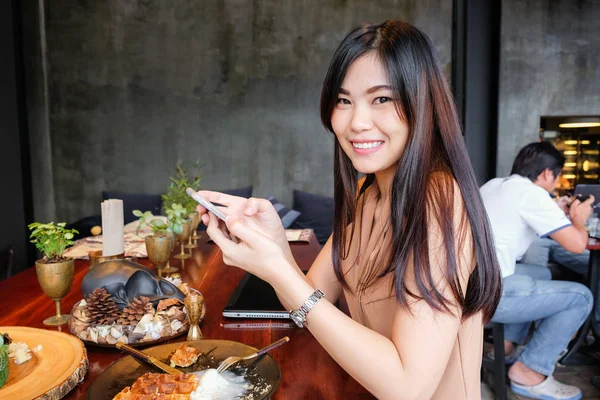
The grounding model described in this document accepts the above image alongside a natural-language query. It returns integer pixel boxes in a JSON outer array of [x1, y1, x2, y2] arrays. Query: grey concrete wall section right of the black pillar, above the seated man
[[496, 0, 600, 176]]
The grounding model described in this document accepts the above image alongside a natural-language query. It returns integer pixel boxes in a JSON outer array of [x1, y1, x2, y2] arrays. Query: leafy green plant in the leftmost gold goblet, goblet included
[[28, 222, 79, 326]]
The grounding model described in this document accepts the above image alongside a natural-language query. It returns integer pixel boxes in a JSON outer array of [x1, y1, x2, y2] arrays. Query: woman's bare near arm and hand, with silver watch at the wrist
[[209, 188, 473, 399]]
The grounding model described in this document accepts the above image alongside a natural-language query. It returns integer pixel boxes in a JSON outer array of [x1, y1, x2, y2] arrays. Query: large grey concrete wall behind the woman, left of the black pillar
[[25, 0, 452, 221]]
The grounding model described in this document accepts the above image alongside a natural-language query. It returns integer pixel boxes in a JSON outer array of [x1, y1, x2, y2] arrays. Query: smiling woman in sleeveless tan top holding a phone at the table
[[198, 21, 500, 400]]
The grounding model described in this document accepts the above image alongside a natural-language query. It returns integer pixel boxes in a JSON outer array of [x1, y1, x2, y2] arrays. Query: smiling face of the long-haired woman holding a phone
[[331, 54, 408, 176]]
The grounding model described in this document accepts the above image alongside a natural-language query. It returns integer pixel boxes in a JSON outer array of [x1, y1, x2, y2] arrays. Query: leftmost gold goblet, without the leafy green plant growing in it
[[35, 259, 75, 326]]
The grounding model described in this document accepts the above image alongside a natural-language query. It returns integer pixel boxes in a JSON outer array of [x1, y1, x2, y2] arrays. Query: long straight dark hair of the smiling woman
[[321, 21, 501, 321]]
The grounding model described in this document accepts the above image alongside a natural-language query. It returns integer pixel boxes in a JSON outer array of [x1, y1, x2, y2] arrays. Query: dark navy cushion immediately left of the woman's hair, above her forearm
[[292, 190, 334, 244]]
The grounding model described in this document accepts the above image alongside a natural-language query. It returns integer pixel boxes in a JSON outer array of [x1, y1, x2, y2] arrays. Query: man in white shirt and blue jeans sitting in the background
[[481, 142, 594, 400]]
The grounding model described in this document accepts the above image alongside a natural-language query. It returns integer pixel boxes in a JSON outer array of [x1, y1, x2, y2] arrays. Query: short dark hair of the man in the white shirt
[[510, 142, 565, 182]]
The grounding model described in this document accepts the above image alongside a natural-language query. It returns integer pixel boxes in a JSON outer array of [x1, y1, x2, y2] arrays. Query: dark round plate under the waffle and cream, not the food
[[87, 340, 281, 400]]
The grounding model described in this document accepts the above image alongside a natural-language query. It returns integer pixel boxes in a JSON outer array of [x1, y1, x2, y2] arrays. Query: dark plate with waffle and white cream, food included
[[87, 340, 281, 400]]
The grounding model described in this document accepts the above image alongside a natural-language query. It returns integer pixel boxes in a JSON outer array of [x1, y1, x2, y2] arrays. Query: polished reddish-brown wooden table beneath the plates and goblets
[[0, 233, 373, 400]]
